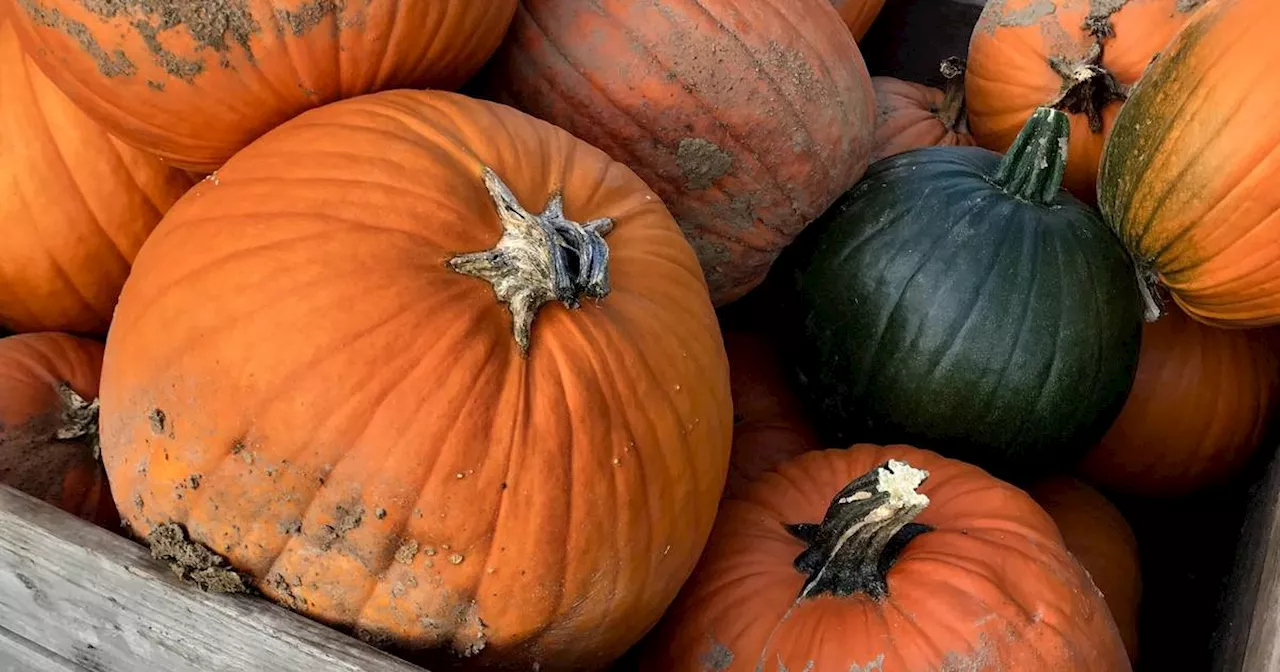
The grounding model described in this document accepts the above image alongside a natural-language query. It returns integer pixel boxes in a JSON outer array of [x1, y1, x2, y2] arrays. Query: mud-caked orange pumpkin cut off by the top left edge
[[4, 0, 516, 173]]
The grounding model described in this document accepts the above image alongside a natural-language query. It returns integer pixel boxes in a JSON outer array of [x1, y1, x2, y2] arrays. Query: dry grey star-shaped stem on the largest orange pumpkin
[[449, 166, 613, 357]]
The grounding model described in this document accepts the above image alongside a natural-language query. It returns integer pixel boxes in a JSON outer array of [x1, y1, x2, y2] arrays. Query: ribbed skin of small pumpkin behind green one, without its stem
[[872, 77, 974, 161]]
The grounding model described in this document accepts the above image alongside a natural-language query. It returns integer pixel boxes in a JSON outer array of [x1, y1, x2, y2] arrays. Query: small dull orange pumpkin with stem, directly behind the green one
[[872, 59, 973, 161]]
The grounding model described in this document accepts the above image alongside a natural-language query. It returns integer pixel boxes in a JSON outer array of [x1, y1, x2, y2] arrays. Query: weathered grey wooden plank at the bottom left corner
[[0, 485, 422, 672]]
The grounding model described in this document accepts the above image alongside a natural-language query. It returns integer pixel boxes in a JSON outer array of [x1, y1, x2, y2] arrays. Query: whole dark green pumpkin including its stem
[[781, 109, 1142, 479]]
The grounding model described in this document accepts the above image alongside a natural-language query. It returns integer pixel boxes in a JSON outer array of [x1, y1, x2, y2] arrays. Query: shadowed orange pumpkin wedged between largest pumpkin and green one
[[724, 332, 819, 497]]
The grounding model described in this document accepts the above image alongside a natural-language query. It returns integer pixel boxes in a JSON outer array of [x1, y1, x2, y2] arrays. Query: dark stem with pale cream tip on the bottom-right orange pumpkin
[[787, 460, 931, 599]]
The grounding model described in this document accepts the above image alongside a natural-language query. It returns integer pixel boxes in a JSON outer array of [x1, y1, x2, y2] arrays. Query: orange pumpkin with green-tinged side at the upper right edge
[[1098, 0, 1280, 326]]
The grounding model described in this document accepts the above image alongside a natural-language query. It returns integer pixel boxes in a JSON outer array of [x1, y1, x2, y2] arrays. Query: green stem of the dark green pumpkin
[[992, 108, 1071, 205]]
